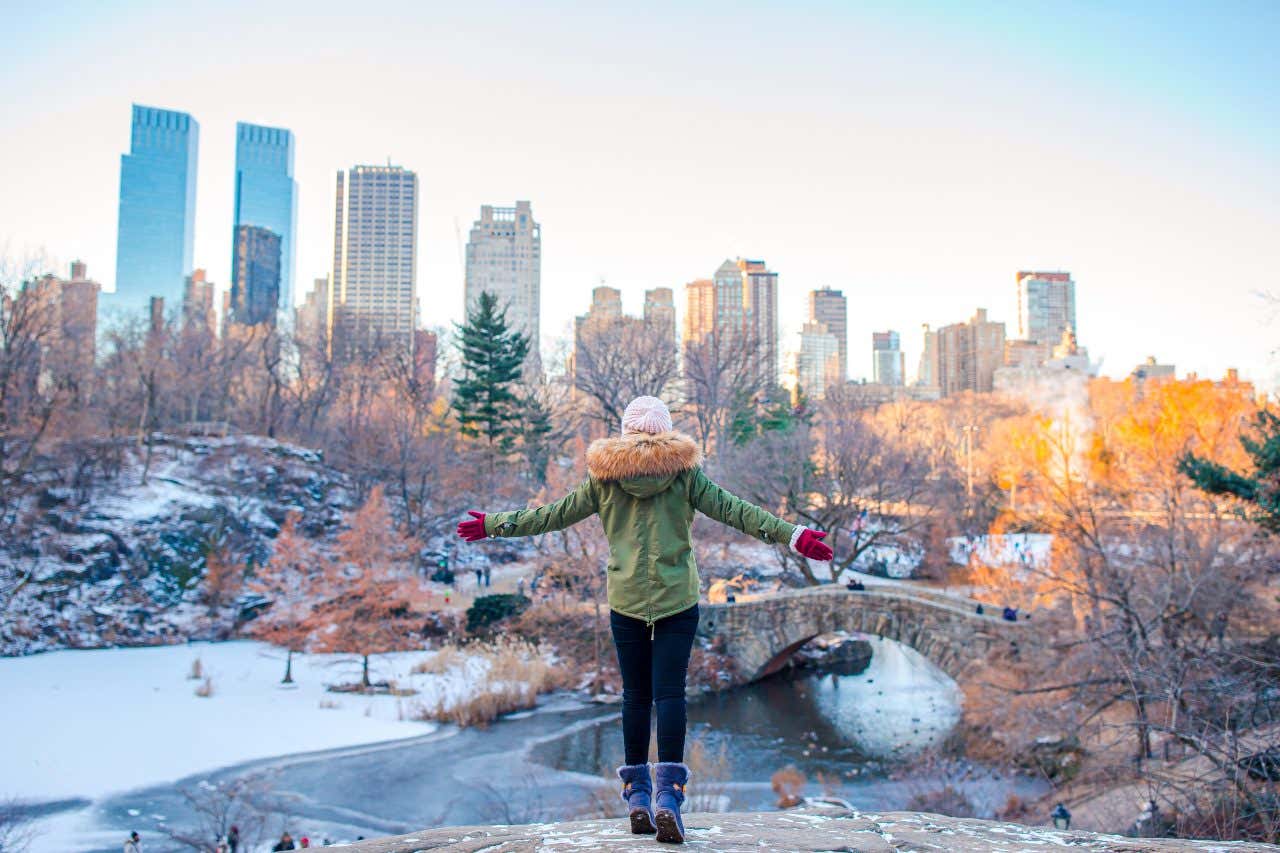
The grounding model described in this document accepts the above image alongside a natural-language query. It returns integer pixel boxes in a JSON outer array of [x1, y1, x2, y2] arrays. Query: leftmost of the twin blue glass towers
[[109, 104, 200, 314]]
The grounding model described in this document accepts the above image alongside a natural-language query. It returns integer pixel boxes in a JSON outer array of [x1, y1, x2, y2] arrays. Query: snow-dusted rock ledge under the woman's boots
[[346, 808, 1280, 853]]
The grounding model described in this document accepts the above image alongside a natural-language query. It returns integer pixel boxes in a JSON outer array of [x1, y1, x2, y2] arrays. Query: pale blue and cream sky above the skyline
[[0, 0, 1280, 389]]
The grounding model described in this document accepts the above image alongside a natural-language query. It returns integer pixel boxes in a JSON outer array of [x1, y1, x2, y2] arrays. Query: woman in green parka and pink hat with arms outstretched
[[458, 397, 831, 844]]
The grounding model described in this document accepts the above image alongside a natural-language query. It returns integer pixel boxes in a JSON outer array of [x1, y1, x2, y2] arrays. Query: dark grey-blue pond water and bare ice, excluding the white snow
[[36, 642, 1042, 853]]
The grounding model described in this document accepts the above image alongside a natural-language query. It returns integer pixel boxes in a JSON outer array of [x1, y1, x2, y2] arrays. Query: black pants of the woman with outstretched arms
[[609, 605, 698, 765]]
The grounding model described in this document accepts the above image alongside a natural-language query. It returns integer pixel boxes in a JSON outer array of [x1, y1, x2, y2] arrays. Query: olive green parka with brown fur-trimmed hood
[[485, 433, 797, 624]]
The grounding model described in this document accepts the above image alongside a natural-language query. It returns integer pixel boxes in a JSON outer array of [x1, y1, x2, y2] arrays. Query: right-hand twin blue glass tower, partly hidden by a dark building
[[232, 122, 298, 316]]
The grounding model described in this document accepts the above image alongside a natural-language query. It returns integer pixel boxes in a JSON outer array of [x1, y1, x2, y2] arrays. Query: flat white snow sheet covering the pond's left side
[[0, 642, 485, 800]]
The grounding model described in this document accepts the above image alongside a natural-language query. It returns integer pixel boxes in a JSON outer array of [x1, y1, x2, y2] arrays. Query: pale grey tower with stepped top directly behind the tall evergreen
[[466, 201, 543, 364]]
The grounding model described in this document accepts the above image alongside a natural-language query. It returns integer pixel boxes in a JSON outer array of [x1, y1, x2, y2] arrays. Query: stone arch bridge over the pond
[[698, 585, 1033, 683]]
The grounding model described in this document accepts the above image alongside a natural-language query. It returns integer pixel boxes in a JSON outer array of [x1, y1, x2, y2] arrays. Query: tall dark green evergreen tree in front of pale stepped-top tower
[[453, 291, 529, 452]]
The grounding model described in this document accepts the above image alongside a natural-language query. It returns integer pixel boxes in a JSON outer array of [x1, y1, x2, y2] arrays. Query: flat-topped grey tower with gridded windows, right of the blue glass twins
[[328, 165, 417, 357]]
